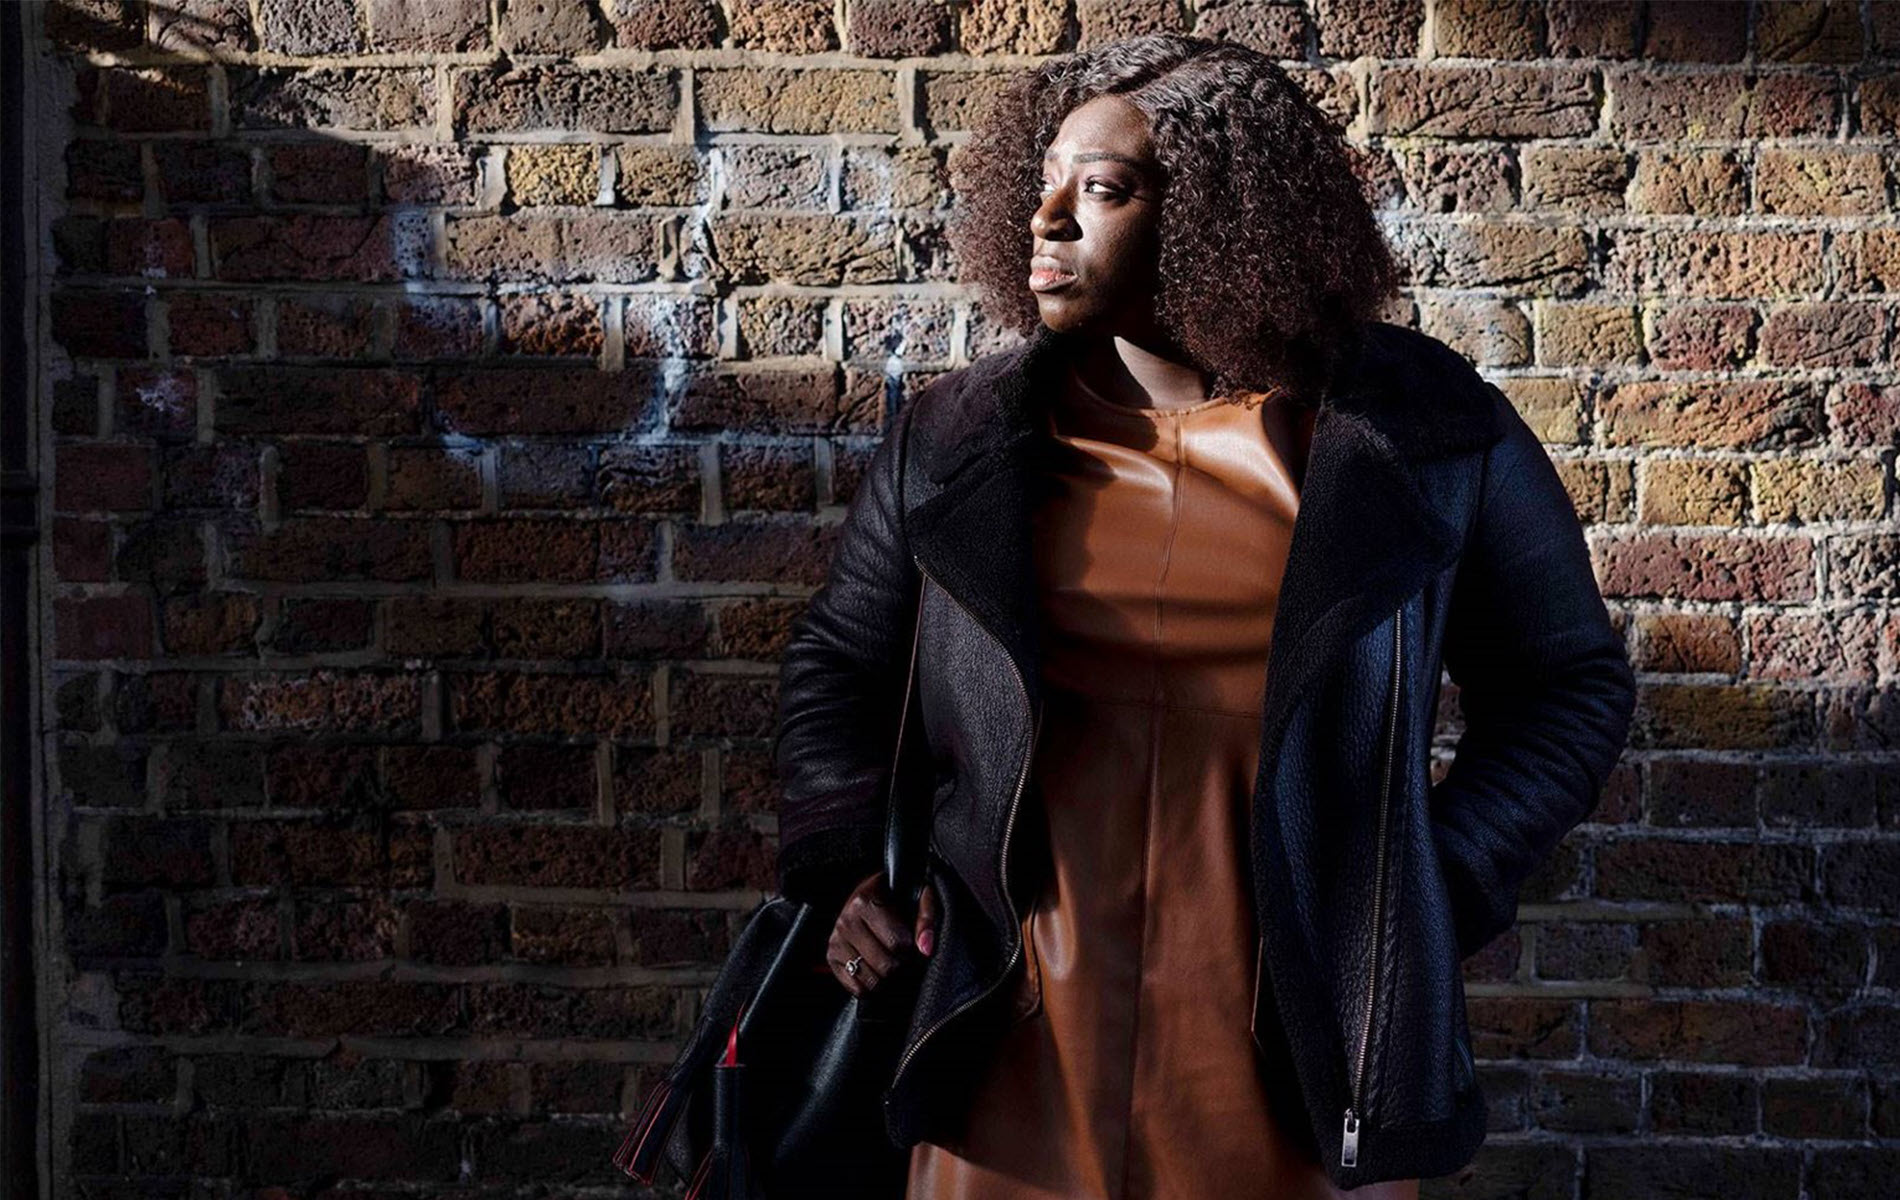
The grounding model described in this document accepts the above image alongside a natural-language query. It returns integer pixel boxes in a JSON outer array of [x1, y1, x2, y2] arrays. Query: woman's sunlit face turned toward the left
[[1028, 95, 1161, 338]]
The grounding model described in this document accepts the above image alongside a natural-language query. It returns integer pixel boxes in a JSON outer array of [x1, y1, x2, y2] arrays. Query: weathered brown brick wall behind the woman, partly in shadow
[[29, 0, 1900, 1200]]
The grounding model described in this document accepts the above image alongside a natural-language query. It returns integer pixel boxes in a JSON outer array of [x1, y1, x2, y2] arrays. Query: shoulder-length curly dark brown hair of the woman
[[946, 34, 1402, 404]]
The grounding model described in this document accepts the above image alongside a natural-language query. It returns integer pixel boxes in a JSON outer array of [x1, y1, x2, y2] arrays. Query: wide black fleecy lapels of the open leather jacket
[[904, 323, 1501, 731]]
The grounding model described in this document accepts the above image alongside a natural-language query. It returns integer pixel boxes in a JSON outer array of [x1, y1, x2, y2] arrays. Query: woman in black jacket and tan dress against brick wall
[[777, 36, 1634, 1200]]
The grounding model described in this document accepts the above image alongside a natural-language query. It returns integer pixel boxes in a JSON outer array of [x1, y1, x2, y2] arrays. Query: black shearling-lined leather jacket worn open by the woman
[[775, 321, 1636, 1189]]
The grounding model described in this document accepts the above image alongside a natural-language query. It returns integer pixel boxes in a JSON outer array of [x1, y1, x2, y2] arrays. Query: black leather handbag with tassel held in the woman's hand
[[614, 592, 929, 1200]]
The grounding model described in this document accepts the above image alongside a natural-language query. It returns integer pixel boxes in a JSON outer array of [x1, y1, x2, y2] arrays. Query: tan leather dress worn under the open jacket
[[906, 368, 1417, 1200]]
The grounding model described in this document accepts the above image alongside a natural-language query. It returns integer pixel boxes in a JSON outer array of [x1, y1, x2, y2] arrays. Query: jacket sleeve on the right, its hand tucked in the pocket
[[1431, 382, 1636, 957]]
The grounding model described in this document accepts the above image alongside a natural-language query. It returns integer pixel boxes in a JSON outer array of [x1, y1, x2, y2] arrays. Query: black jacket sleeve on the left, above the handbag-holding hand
[[773, 397, 922, 906]]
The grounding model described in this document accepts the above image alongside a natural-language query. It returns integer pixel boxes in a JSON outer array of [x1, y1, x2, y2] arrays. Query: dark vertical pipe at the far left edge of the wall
[[0, 4, 40, 1200]]
